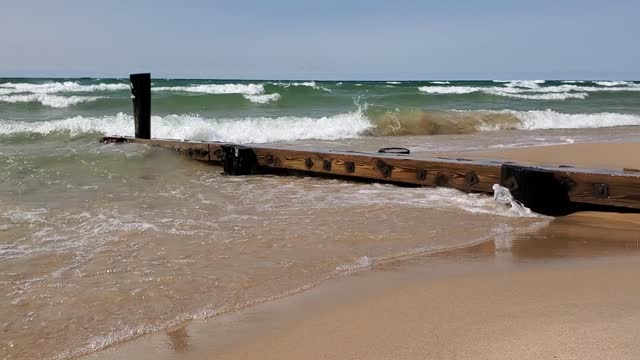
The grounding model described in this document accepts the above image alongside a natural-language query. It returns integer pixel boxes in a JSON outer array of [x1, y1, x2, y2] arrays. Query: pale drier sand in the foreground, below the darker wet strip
[[215, 257, 640, 359]]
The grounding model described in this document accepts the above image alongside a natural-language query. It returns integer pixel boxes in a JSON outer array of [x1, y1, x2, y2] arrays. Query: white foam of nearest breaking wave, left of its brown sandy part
[[0, 110, 374, 143]]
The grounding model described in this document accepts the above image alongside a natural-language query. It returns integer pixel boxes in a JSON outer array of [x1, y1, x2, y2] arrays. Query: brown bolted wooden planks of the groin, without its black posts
[[103, 137, 640, 209]]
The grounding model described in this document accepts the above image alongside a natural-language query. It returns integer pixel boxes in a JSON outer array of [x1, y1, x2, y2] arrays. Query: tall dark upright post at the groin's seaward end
[[129, 74, 151, 139]]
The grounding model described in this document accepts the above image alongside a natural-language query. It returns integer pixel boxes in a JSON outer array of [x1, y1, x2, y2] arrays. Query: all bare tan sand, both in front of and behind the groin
[[82, 144, 640, 359]]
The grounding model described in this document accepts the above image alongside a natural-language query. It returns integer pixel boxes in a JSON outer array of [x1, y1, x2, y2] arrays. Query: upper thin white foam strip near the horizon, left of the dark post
[[0, 81, 130, 95]]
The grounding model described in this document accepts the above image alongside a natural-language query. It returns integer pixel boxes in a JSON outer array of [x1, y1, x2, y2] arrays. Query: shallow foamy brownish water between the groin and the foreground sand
[[0, 134, 560, 359]]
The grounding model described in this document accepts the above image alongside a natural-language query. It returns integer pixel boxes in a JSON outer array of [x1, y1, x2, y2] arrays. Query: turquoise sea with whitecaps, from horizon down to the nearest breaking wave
[[0, 79, 640, 142]]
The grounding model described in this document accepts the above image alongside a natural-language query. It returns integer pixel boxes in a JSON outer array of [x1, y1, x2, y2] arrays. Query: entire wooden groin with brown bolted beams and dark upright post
[[102, 74, 640, 215]]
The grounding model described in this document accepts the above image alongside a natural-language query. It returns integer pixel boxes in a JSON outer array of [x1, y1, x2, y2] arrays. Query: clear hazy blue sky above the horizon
[[0, 0, 640, 80]]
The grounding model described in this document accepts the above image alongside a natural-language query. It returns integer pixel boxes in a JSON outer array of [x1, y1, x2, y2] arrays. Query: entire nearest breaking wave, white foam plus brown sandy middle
[[0, 109, 640, 143]]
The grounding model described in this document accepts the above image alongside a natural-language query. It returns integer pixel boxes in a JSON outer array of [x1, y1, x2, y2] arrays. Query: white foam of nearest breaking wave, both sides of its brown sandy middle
[[0, 110, 640, 143]]
